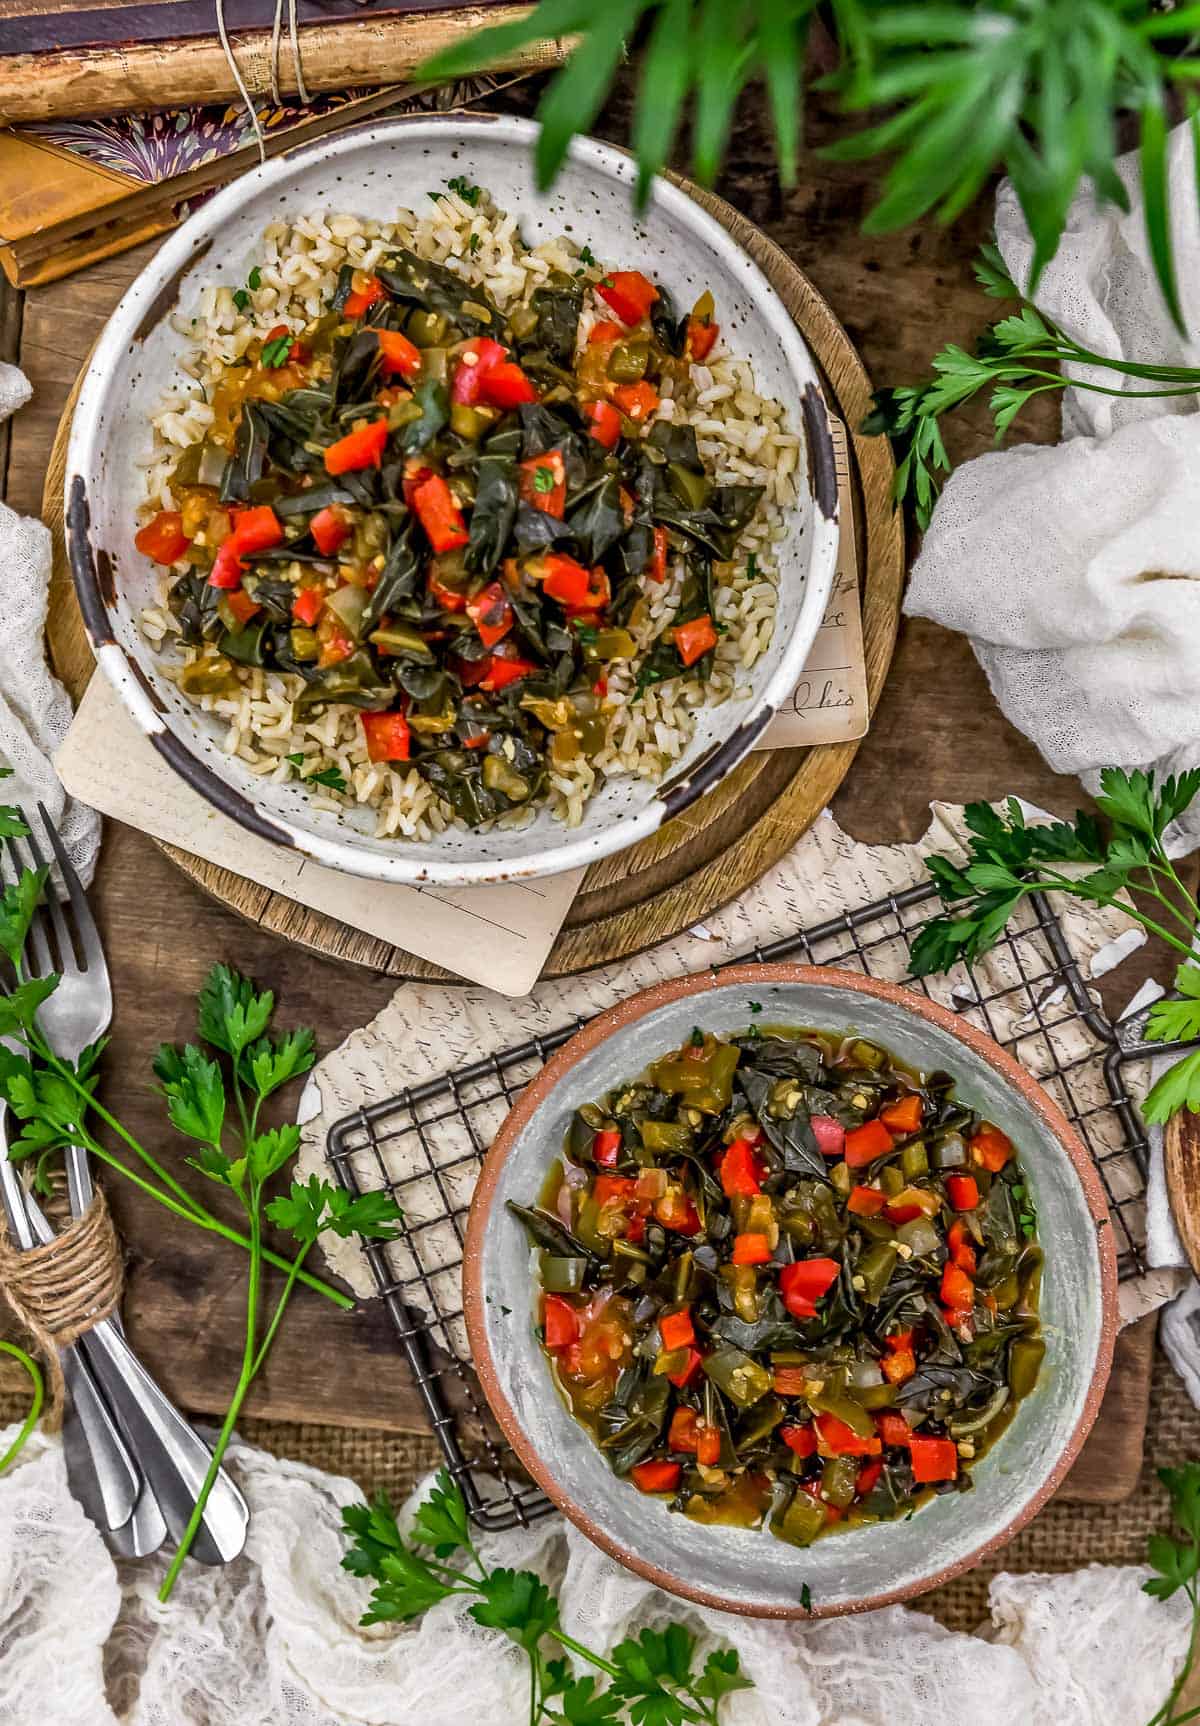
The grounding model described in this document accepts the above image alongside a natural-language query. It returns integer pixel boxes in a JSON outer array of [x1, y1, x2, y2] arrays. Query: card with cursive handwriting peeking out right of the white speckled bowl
[[756, 416, 870, 749]]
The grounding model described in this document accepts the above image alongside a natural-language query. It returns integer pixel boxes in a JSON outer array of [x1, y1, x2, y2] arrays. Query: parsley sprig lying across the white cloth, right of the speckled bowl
[[862, 245, 1200, 528]]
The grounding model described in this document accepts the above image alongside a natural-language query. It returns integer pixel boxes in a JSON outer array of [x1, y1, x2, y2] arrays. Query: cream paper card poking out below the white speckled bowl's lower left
[[54, 673, 584, 994]]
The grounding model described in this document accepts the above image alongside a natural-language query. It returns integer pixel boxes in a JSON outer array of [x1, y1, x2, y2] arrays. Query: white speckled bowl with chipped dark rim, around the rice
[[66, 116, 837, 885]]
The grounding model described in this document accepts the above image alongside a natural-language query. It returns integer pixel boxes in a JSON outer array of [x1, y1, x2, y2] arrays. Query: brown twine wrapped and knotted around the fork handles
[[0, 1187, 124, 1433]]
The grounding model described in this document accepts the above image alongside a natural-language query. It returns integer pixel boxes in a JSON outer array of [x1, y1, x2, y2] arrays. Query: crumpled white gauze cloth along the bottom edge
[[0, 1429, 1188, 1726]]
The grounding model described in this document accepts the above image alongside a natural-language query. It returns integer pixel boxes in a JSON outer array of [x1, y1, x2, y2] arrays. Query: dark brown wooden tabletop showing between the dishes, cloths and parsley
[[0, 70, 1187, 1424]]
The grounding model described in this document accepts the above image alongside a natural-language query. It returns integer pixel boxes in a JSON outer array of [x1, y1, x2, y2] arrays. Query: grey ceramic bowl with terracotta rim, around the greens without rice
[[464, 965, 1117, 1617]]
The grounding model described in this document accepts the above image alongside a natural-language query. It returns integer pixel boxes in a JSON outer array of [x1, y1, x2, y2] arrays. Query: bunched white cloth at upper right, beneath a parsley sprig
[[905, 126, 1200, 849]]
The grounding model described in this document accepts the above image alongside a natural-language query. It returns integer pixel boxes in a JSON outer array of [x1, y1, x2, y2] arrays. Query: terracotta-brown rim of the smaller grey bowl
[[463, 965, 1117, 1619]]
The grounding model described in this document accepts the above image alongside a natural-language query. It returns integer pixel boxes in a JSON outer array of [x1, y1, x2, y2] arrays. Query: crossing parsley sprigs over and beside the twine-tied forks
[[0, 783, 401, 1600]]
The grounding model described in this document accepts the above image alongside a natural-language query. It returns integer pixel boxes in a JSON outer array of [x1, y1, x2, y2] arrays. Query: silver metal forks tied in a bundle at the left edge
[[0, 804, 249, 1564]]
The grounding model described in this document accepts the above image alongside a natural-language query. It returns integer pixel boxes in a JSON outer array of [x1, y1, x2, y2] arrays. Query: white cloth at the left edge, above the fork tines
[[0, 362, 100, 885]]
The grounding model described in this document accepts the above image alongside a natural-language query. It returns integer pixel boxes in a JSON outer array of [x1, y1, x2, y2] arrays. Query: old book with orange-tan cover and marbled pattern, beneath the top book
[[0, 72, 542, 288]]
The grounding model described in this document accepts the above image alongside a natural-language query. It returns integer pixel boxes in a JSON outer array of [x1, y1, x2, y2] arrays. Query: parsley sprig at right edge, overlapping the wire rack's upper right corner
[[910, 768, 1200, 1122]]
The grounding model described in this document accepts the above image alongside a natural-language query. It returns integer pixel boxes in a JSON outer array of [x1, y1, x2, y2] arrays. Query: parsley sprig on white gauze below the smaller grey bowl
[[342, 1469, 751, 1726]]
